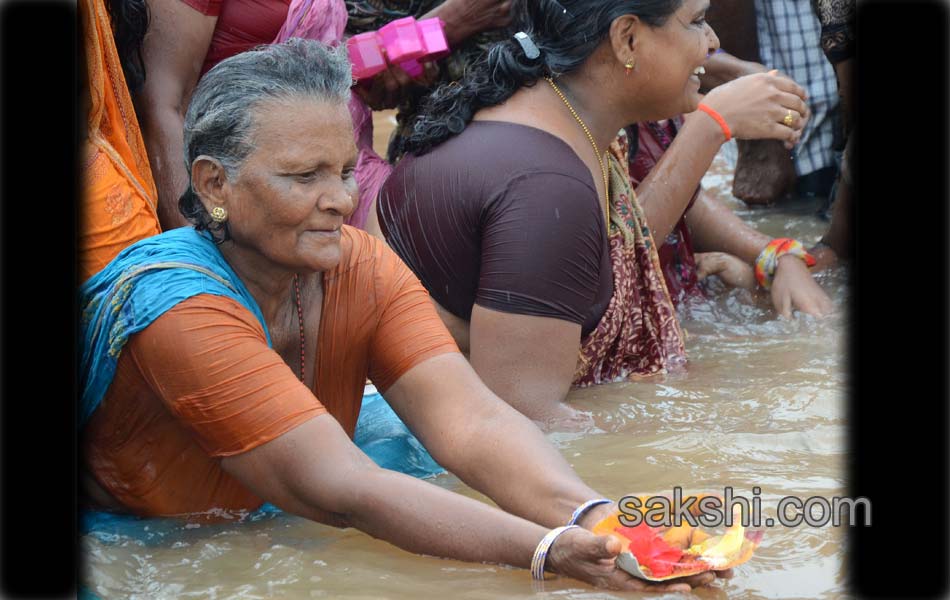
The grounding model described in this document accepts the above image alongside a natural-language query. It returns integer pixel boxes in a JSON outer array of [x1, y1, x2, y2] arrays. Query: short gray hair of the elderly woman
[[178, 38, 353, 241]]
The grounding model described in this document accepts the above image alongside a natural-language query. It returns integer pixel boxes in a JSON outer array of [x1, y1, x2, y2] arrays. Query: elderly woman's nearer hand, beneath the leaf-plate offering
[[547, 529, 732, 592]]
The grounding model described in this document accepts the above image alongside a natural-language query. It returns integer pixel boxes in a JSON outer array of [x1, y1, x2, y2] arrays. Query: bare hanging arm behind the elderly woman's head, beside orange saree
[[136, 0, 218, 231]]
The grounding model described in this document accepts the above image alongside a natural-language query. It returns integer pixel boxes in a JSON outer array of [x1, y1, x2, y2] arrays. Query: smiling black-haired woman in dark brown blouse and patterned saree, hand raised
[[377, 0, 821, 422]]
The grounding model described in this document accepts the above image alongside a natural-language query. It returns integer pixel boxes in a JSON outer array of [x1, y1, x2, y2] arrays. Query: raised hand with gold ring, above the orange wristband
[[703, 71, 811, 149]]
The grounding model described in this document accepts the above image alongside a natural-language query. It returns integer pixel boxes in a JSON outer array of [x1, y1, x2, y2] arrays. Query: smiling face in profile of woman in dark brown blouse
[[636, 0, 719, 120]]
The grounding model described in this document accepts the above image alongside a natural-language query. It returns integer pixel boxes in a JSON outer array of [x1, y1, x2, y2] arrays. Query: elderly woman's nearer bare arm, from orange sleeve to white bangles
[[222, 415, 546, 567]]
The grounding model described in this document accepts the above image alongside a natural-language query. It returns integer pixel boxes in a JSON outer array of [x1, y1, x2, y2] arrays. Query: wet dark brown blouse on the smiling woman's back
[[378, 121, 613, 334]]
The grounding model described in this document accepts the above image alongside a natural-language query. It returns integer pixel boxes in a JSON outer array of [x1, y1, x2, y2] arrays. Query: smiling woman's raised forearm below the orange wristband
[[637, 112, 724, 240]]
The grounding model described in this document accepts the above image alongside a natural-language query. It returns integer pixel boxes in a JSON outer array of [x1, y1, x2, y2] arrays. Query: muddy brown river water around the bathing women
[[81, 114, 848, 599]]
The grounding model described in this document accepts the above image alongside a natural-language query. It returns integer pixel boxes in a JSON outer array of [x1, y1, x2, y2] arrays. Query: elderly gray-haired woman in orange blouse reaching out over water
[[80, 40, 736, 590]]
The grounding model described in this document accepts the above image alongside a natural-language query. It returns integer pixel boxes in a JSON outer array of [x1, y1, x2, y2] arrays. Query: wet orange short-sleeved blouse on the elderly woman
[[82, 227, 458, 516]]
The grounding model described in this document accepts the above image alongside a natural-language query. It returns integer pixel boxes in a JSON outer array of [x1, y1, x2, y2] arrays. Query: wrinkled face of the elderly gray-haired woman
[[227, 98, 357, 272]]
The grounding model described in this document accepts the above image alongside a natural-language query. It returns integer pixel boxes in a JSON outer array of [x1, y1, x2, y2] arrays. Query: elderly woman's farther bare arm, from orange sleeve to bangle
[[385, 350, 597, 527]]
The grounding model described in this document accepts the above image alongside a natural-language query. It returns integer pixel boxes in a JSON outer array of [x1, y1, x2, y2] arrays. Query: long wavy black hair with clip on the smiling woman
[[402, 0, 683, 154]]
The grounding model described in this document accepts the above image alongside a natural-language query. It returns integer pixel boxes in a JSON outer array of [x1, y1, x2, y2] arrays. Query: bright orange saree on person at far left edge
[[78, 0, 161, 283]]
